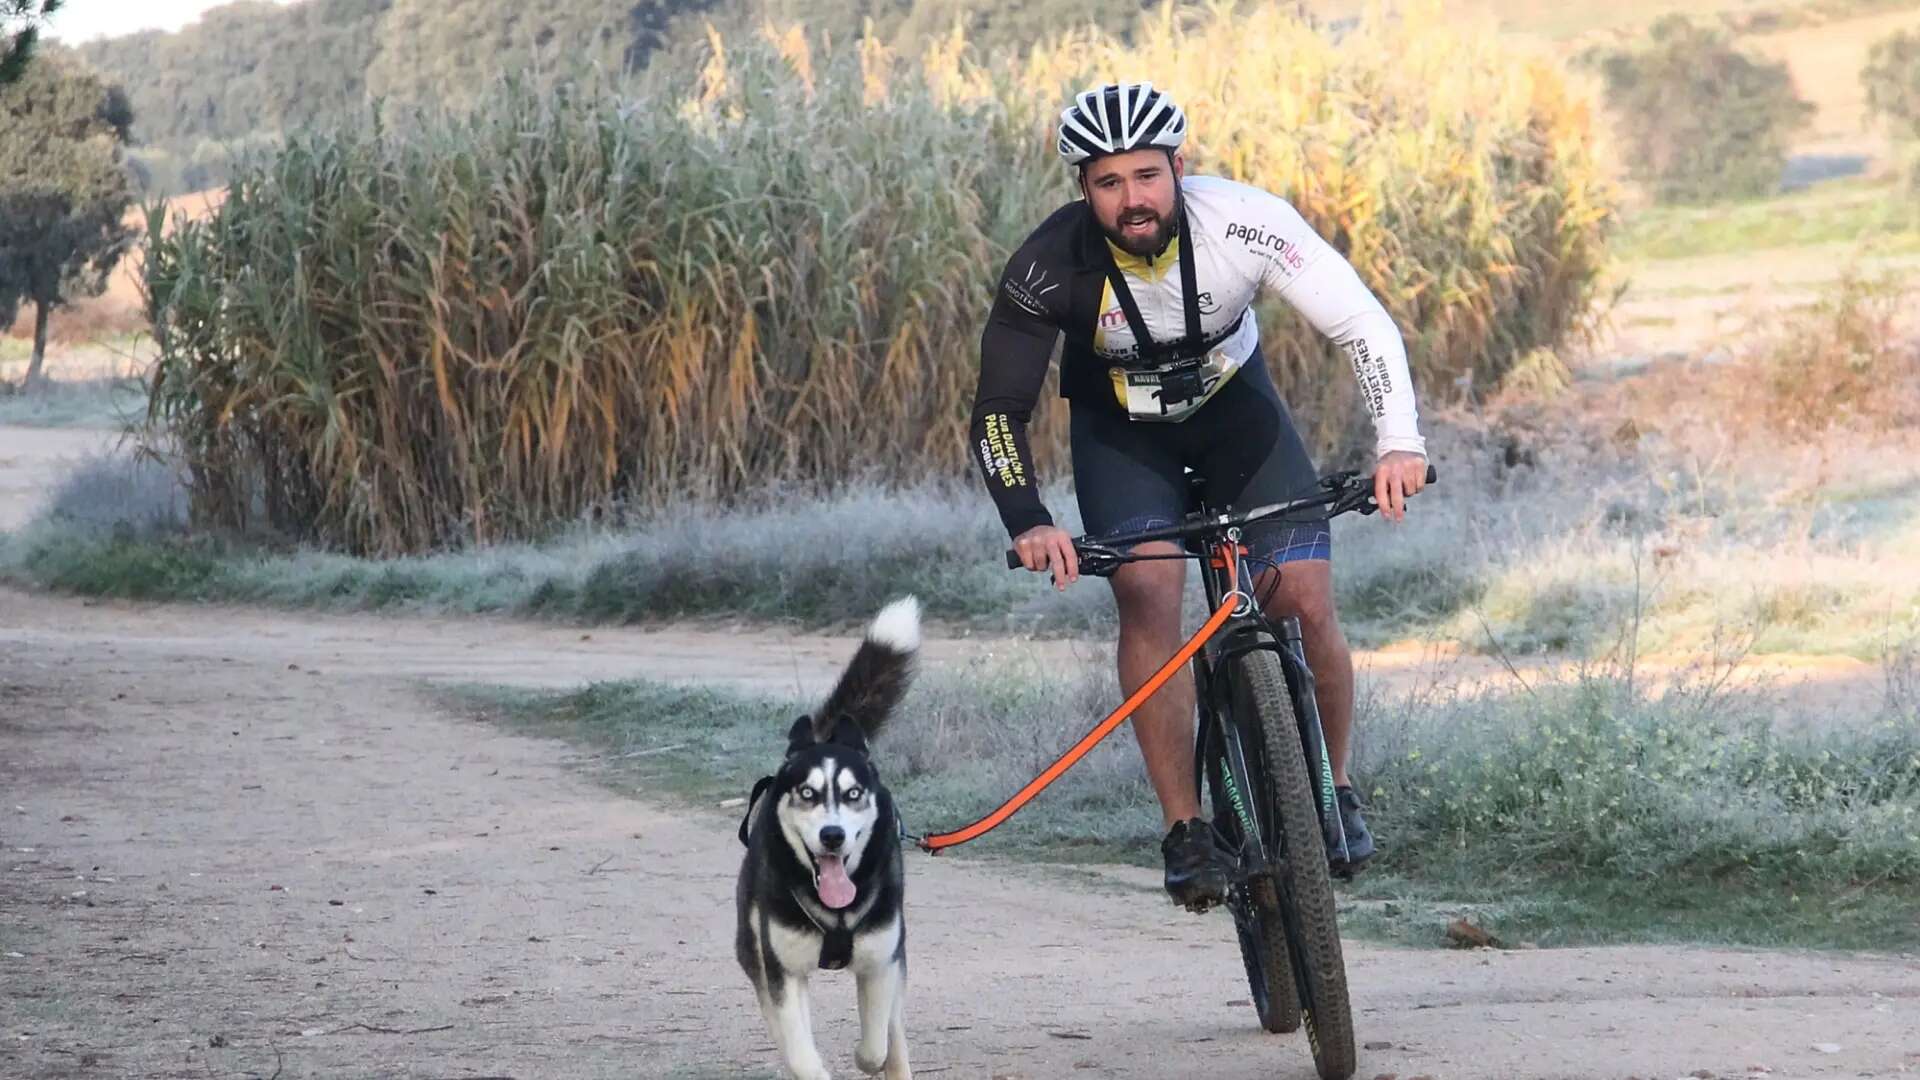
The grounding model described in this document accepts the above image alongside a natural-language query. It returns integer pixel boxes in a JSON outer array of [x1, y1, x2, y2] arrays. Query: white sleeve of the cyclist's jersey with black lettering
[[1261, 196, 1427, 455]]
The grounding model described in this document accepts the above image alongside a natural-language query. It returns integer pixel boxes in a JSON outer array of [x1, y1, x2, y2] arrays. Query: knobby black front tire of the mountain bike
[[1227, 650, 1357, 1080]]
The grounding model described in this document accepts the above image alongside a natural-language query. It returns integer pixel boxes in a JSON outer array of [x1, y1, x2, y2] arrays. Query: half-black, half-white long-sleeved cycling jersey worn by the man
[[970, 177, 1427, 536]]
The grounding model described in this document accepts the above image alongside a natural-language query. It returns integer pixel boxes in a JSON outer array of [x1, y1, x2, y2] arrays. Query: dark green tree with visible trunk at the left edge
[[0, 56, 136, 386]]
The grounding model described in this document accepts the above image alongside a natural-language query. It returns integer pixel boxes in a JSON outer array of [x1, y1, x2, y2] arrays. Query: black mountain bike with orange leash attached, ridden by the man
[[1008, 467, 1436, 1080]]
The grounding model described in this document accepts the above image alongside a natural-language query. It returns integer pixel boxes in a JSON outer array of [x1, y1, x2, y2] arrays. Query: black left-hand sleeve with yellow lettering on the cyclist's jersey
[[968, 256, 1060, 536]]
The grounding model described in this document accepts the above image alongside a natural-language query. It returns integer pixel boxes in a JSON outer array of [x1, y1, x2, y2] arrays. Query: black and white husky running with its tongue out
[[733, 596, 920, 1080]]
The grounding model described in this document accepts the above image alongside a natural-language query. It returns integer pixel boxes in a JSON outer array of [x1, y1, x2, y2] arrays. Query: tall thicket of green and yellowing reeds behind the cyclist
[[148, 6, 1611, 553]]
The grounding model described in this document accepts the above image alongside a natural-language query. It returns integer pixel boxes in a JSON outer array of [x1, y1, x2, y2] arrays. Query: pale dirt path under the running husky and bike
[[0, 592, 1920, 1078]]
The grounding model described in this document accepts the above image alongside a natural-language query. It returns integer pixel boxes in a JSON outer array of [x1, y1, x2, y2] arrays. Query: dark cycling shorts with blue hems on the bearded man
[[1071, 350, 1332, 563]]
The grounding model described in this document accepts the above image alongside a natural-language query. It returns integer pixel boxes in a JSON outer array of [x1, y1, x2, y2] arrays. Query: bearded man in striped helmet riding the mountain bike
[[972, 83, 1427, 907]]
